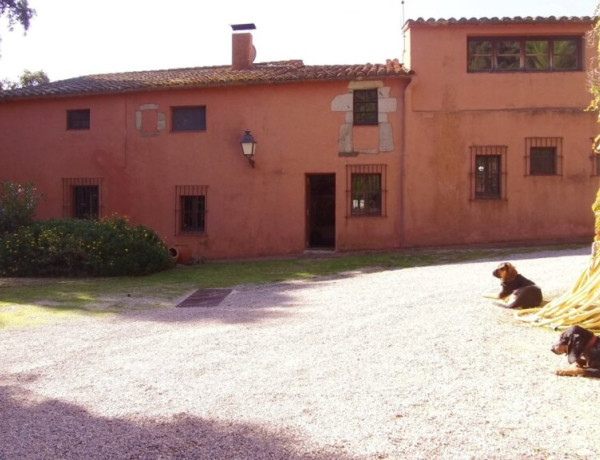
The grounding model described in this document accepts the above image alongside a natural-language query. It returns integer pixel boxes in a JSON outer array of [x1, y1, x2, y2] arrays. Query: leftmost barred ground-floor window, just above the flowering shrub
[[62, 177, 102, 219]]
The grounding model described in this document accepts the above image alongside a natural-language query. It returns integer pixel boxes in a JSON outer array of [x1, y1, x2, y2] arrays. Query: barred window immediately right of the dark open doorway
[[346, 164, 387, 217]]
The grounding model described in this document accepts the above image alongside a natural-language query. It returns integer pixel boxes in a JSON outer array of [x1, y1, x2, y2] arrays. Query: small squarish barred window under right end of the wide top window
[[525, 137, 563, 176]]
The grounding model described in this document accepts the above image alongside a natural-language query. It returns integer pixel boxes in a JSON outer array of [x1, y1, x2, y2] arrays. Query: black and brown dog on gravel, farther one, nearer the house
[[492, 262, 543, 308]]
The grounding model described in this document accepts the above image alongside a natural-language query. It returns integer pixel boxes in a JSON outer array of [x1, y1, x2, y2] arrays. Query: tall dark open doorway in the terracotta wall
[[306, 174, 335, 249]]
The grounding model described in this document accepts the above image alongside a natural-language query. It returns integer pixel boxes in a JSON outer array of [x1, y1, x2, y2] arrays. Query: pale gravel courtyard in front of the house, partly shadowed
[[0, 249, 600, 460]]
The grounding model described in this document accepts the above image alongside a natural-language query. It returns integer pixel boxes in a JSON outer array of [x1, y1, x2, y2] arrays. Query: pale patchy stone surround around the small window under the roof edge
[[331, 81, 398, 156]]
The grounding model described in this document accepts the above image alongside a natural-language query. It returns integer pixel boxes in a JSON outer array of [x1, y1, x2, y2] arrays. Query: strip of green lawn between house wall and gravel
[[0, 245, 581, 329]]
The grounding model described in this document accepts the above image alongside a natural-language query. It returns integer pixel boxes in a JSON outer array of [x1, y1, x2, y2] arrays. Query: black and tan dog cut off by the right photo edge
[[551, 326, 600, 377]]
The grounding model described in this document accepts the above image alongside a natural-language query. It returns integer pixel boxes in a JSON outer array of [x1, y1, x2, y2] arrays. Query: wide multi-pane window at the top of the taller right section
[[467, 37, 582, 72]]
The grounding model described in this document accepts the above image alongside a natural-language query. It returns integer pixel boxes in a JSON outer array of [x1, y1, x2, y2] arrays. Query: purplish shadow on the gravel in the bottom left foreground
[[0, 386, 354, 460]]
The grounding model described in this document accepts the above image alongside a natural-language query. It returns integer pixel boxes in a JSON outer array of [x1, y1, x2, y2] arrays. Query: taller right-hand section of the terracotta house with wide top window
[[402, 18, 599, 246]]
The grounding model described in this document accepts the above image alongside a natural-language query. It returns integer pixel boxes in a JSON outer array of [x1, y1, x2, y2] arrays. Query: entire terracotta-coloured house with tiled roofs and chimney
[[0, 18, 600, 262]]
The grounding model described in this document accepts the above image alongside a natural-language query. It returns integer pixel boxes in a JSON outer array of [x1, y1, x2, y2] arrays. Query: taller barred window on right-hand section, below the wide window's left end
[[469, 145, 508, 200]]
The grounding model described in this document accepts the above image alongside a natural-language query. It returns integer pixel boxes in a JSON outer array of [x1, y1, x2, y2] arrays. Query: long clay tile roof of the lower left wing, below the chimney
[[0, 59, 411, 101]]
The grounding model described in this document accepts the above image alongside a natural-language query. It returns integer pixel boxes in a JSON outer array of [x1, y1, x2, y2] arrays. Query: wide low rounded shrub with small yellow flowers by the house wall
[[0, 217, 173, 277]]
